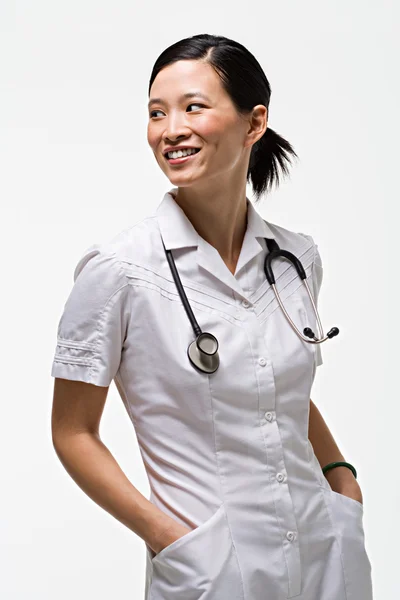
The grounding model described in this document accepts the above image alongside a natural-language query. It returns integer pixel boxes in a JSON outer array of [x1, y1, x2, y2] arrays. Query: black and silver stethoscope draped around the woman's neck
[[162, 238, 339, 373]]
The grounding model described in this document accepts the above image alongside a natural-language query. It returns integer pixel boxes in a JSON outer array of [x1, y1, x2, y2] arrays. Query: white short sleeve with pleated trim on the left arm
[[51, 244, 130, 387]]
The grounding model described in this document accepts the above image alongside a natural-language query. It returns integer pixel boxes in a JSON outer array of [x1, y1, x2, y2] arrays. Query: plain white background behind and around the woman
[[0, 0, 400, 600]]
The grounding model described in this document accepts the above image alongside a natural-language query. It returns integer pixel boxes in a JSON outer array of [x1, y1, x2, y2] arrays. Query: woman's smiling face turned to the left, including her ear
[[147, 60, 266, 187]]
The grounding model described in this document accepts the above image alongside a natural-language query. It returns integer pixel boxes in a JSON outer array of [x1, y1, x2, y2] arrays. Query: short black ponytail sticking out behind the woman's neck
[[247, 127, 298, 202]]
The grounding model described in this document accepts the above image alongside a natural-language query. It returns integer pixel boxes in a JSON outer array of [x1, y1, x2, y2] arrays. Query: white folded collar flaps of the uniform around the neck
[[156, 188, 275, 250]]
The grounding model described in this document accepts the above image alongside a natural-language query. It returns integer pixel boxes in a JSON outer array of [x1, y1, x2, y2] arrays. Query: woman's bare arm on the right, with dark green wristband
[[308, 399, 363, 503]]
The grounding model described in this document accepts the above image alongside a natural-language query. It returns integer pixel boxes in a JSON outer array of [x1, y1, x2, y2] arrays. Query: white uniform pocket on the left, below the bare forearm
[[149, 504, 244, 600]]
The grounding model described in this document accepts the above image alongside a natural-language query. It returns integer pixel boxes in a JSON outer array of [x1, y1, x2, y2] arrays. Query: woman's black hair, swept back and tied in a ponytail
[[148, 33, 297, 202]]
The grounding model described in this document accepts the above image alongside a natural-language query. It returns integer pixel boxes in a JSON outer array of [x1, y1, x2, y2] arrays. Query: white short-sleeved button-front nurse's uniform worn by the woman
[[51, 188, 372, 600]]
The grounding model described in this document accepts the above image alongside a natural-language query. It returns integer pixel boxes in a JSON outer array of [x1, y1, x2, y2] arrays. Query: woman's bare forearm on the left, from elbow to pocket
[[54, 432, 177, 549]]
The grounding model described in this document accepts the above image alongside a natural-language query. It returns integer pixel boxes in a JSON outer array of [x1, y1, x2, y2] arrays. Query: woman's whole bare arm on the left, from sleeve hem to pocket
[[51, 377, 190, 554]]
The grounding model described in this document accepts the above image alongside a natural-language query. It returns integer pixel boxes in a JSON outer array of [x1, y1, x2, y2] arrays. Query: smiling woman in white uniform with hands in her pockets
[[52, 35, 372, 600]]
